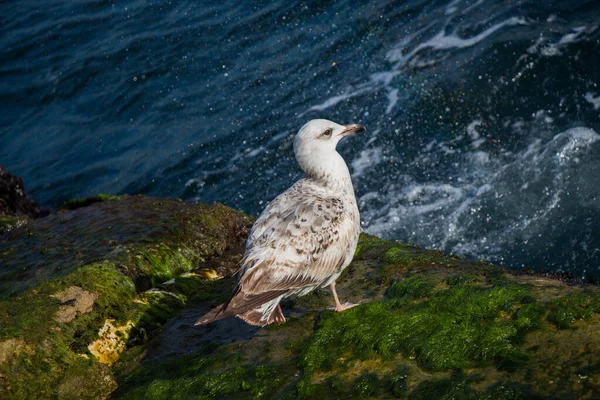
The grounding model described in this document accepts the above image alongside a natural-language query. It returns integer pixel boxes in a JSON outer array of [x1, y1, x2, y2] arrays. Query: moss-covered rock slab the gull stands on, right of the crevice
[[114, 235, 600, 400]]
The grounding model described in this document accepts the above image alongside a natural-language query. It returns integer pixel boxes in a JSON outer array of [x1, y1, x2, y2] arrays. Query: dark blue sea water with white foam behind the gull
[[0, 0, 600, 275]]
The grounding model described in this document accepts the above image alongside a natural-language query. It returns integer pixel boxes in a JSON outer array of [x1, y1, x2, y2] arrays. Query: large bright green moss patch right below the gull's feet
[[300, 277, 539, 376]]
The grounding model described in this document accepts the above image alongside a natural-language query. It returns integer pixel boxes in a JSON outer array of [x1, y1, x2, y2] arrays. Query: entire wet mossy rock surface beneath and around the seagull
[[0, 196, 600, 399]]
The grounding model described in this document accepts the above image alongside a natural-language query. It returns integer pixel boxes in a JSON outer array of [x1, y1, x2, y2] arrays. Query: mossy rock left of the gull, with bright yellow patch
[[0, 196, 251, 399]]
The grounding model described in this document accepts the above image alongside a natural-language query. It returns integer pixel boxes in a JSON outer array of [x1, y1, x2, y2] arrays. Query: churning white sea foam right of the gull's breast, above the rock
[[360, 125, 600, 262]]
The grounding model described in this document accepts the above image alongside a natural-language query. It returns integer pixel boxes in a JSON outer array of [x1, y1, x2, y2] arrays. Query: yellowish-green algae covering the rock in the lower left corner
[[0, 263, 135, 399]]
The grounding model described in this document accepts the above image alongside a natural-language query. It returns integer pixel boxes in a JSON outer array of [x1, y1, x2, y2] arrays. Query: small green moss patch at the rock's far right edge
[[548, 291, 600, 329]]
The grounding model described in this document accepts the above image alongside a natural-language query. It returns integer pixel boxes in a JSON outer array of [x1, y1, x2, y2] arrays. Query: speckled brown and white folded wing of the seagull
[[224, 181, 359, 313]]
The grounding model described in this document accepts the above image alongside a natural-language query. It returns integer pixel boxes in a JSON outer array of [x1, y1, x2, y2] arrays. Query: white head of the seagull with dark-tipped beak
[[294, 119, 365, 179]]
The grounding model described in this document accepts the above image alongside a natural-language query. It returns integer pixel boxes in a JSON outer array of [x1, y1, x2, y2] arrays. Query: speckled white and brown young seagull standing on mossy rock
[[196, 119, 365, 326]]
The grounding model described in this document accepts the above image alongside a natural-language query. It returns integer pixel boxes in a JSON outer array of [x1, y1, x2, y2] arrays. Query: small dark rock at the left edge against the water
[[0, 165, 40, 218]]
